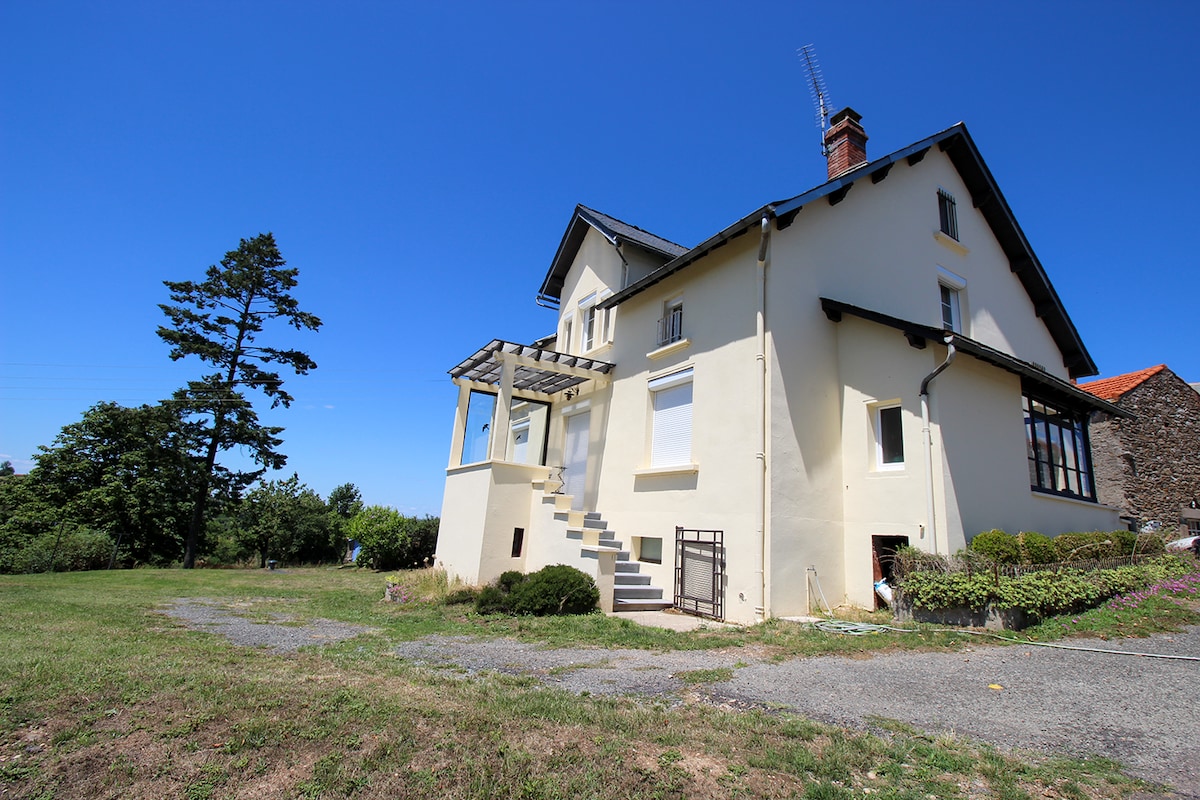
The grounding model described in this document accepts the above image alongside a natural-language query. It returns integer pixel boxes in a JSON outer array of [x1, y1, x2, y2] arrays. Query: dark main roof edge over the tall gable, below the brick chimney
[[600, 122, 1099, 378]]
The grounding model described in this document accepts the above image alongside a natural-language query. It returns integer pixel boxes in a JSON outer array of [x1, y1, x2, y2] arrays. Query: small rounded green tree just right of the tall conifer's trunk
[[239, 474, 337, 566]]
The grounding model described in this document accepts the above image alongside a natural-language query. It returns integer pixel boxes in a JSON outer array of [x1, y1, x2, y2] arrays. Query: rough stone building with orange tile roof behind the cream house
[[1079, 363, 1200, 536]]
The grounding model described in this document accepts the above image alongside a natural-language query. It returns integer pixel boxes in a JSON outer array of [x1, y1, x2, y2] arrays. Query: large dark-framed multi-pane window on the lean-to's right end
[[1021, 395, 1096, 500]]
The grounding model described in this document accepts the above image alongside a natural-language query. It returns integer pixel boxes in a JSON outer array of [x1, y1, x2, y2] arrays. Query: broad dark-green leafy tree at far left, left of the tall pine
[[5, 403, 196, 563]]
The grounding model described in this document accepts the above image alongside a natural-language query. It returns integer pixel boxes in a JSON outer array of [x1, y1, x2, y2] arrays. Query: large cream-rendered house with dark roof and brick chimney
[[437, 109, 1126, 622]]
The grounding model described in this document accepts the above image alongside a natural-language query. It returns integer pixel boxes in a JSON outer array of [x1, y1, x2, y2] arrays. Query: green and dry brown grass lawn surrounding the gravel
[[0, 569, 1198, 800]]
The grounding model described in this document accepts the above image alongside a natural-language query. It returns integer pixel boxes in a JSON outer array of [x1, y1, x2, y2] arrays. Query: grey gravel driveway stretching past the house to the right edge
[[396, 627, 1200, 798]]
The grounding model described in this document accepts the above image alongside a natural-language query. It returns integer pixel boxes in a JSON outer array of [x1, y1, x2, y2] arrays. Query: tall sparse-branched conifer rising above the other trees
[[158, 233, 320, 569]]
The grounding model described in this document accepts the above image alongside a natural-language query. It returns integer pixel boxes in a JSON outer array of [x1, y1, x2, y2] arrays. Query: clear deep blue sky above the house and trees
[[0, 0, 1200, 515]]
